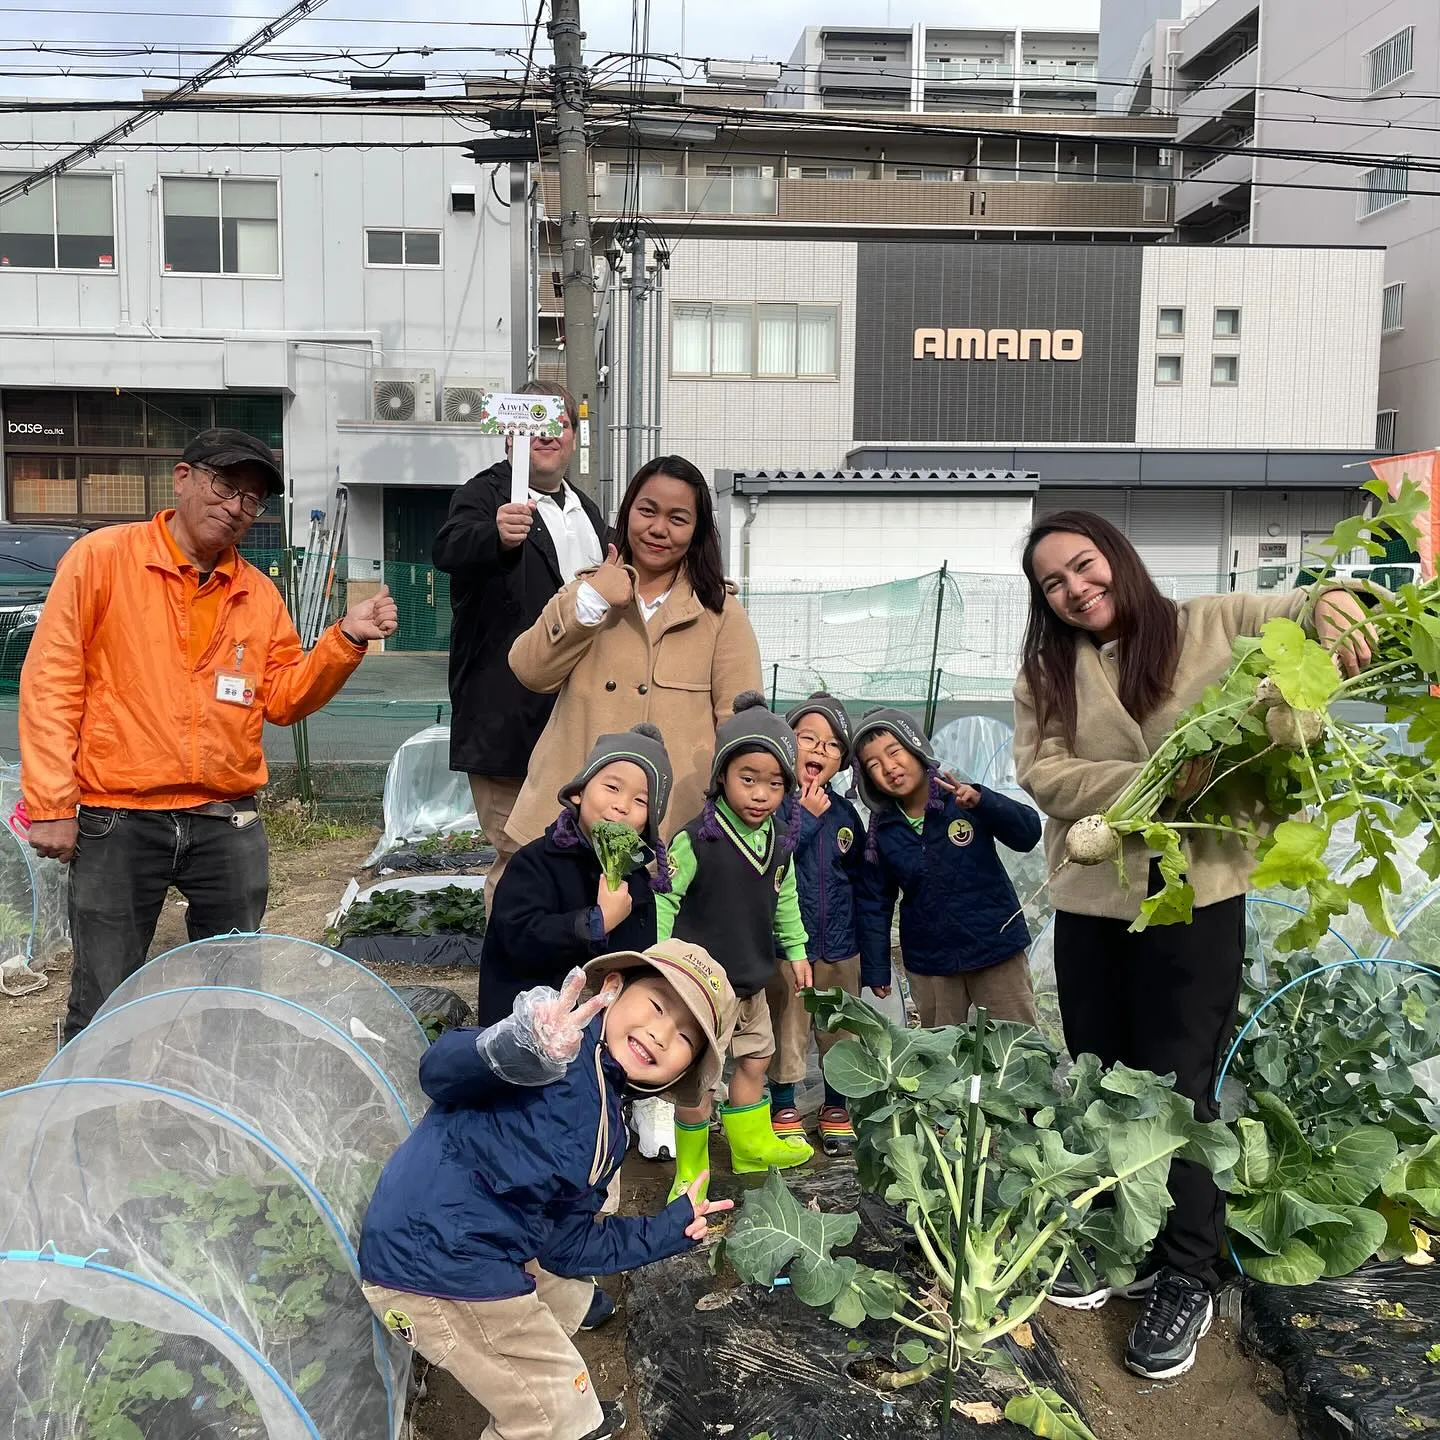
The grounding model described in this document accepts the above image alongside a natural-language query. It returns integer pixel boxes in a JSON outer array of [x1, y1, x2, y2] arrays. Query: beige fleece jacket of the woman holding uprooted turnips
[[1015, 590, 1305, 920]]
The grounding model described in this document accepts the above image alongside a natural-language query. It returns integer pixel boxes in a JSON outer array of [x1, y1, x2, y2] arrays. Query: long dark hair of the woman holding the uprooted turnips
[[1020, 510, 1179, 744]]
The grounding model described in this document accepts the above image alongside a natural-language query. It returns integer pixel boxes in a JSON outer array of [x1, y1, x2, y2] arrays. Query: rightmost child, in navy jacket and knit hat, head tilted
[[854, 708, 1041, 1028]]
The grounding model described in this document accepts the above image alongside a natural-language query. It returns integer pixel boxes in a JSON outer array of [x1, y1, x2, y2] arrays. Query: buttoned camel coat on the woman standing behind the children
[[505, 575, 760, 845]]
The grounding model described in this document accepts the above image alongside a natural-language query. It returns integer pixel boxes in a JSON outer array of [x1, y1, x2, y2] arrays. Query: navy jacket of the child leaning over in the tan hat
[[360, 1015, 694, 1300]]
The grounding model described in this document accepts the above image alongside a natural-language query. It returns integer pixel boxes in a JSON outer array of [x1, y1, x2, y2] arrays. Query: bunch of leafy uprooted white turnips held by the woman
[[1066, 481, 1440, 949]]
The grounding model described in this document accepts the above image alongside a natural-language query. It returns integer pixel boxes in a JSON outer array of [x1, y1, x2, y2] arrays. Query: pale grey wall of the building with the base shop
[[0, 104, 510, 556]]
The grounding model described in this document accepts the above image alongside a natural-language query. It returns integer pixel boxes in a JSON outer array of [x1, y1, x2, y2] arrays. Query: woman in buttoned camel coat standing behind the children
[[505, 455, 760, 845]]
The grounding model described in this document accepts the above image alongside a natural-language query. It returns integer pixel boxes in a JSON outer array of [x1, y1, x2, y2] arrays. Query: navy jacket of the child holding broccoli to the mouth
[[475, 825, 655, 1027]]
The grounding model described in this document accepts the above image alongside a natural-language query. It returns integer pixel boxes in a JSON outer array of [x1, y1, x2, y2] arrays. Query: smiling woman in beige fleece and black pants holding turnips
[[1015, 510, 1369, 1380]]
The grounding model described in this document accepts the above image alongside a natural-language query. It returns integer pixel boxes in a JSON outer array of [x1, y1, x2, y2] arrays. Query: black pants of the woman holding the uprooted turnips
[[1056, 896, 1246, 1290]]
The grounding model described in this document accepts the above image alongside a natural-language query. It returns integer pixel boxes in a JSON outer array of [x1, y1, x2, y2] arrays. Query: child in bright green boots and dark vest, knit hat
[[657, 690, 815, 1195]]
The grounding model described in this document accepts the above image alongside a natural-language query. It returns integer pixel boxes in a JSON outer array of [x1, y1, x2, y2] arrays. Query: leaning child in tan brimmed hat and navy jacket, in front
[[360, 940, 736, 1440]]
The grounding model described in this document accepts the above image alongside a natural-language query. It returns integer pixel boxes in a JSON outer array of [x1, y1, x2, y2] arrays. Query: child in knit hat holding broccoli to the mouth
[[477, 723, 671, 1025]]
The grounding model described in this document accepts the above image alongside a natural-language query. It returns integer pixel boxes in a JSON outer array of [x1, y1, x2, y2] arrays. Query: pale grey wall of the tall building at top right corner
[[1253, 0, 1440, 451]]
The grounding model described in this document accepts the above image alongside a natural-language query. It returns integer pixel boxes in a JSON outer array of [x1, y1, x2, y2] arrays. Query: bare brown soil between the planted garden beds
[[0, 835, 1296, 1440]]
